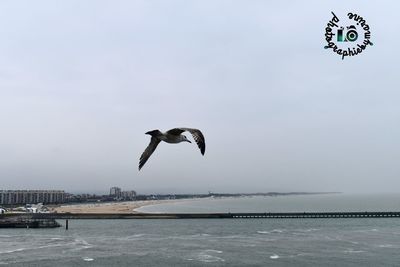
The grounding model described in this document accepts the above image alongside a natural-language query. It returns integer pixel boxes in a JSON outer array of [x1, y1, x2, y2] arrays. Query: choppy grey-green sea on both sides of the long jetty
[[0, 194, 400, 266]]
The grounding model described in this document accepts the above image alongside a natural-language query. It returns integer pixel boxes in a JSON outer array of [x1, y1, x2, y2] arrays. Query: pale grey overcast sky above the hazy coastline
[[0, 0, 400, 193]]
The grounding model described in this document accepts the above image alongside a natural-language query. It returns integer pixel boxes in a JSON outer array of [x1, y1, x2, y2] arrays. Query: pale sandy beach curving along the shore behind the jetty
[[50, 199, 179, 213]]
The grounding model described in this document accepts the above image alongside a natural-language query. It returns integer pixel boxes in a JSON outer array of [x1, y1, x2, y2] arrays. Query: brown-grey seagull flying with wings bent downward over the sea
[[139, 128, 206, 171]]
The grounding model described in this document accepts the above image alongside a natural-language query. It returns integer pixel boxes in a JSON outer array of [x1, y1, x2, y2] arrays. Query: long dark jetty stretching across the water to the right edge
[[28, 212, 400, 219]]
